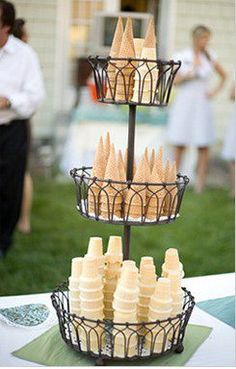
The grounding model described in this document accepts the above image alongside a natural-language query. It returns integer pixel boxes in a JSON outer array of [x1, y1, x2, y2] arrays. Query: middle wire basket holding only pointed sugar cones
[[70, 167, 189, 225]]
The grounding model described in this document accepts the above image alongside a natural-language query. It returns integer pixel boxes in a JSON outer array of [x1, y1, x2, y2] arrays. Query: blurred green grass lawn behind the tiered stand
[[0, 180, 234, 295]]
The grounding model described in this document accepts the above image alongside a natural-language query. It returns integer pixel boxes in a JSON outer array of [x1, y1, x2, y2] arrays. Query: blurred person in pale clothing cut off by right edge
[[222, 86, 236, 198]]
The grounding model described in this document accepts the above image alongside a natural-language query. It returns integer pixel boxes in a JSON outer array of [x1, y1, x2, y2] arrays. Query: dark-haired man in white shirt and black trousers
[[0, 0, 44, 257]]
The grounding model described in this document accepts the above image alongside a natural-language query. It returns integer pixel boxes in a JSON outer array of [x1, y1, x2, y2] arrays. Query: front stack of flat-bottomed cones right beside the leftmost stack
[[79, 255, 104, 352]]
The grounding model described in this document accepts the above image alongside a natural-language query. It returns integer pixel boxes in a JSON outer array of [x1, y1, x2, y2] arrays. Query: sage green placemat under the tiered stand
[[12, 325, 212, 366]]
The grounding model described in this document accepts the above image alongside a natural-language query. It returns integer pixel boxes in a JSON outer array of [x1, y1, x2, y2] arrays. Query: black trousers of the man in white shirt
[[0, 120, 28, 251]]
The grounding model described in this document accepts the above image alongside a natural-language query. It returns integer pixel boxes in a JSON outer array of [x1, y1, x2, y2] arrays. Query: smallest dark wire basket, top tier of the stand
[[88, 56, 181, 106]]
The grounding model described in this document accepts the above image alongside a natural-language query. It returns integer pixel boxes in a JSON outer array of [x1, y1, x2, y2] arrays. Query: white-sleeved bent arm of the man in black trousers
[[5, 50, 45, 118]]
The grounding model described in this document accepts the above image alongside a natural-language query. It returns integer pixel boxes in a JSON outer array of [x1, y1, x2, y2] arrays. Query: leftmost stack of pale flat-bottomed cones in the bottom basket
[[68, 257, 83, 315]]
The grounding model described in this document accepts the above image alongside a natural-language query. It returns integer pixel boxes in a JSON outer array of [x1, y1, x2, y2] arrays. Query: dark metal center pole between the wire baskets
[[124, 105, 136, 260]]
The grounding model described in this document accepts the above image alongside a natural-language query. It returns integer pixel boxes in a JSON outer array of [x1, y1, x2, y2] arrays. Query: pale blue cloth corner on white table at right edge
[[197, 296, 235, 328]]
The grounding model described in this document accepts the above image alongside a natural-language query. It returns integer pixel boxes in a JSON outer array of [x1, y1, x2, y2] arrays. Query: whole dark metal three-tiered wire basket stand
[[52, 56, 194, 365]]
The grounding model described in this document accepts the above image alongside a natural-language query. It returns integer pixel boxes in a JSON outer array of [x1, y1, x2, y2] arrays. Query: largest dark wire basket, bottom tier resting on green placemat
[[51, 283, 195, 362]]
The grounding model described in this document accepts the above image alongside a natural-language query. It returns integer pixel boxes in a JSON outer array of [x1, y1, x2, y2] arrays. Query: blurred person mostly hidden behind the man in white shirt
[[12, 18, 33, 234]]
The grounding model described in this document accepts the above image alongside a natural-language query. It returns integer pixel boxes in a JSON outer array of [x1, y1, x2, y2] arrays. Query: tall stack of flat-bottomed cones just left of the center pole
[[104, 236, 123, 320]]
